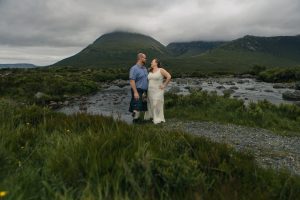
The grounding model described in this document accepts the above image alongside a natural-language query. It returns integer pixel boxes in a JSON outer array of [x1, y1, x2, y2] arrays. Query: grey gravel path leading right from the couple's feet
[[166, 120, 300, 175]]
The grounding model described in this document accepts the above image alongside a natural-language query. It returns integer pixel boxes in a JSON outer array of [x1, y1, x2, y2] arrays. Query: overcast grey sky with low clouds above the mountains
[[0, 0, 300, 65]]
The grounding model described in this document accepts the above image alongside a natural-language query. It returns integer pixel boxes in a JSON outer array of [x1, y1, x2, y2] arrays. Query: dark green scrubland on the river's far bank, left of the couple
[[0, 67, 128, 104]]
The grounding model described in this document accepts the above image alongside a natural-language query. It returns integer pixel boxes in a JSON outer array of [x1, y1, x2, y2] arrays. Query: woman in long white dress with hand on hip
[[144, 58, 171, 124]]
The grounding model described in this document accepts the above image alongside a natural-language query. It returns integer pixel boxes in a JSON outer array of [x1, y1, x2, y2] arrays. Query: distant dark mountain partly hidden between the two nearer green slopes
[[167, 41, 226, 56]]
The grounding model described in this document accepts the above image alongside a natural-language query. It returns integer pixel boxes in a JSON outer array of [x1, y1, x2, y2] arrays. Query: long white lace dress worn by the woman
[[144, 69, 165, 124]]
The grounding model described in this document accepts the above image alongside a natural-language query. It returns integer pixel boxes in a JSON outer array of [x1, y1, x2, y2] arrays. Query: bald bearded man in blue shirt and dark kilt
[[129, 53, 148, 122]]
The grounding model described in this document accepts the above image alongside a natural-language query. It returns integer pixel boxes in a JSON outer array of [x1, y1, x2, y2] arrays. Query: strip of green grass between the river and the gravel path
[[165, 91, 300, 136]]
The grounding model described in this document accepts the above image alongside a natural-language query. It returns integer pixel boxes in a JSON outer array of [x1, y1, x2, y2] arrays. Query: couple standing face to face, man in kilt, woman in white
[[129, 53, 171, 124]]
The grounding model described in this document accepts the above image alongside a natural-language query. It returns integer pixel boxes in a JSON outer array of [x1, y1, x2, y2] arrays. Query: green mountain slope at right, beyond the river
[[167, 35, 300, 72]]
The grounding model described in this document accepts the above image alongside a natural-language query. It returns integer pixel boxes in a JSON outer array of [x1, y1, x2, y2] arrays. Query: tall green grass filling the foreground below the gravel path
[[0, 100, 300, 199]]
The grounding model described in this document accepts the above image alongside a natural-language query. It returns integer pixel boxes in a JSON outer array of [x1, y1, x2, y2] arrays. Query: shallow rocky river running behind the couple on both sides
[[58, 77, 299, 123]]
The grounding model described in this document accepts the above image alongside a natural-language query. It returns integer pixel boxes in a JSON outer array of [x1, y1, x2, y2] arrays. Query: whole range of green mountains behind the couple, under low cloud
[[53, 32, 300, 72]]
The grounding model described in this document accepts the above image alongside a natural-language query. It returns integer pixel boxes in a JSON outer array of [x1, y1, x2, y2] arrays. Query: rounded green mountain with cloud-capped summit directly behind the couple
[[54, 32, 169, 67]]
